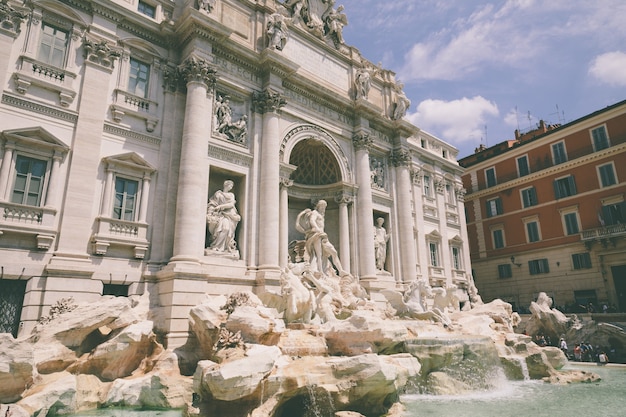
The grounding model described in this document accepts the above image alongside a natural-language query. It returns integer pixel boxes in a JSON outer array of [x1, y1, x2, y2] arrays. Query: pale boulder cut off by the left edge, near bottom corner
[[0, 333, 37, 403]]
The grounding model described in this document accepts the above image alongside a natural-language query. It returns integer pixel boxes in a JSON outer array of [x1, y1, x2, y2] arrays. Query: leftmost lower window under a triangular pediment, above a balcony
[[11, 155, 48, 206]]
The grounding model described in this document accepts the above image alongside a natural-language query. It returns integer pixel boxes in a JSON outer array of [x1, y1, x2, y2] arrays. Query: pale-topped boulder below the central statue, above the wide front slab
[[321, 310, 409, 356]]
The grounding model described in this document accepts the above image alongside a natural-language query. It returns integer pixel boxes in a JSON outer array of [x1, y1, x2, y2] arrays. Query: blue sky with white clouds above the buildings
[[335, 0, 626, 158]]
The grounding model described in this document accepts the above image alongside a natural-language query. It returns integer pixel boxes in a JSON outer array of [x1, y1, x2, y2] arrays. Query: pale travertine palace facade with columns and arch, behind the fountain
[[0, 0, 470, 347]]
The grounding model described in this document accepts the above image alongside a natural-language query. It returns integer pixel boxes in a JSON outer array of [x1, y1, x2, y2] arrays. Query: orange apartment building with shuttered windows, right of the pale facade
[[459, 101, 626, 312]]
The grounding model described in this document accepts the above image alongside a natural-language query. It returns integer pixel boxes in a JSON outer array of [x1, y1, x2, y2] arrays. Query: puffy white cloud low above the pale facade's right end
[[408, 96, 499, 143]]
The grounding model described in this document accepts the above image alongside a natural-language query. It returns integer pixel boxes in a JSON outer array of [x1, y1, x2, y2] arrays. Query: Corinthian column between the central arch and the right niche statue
[[352, 132, 376, 279]]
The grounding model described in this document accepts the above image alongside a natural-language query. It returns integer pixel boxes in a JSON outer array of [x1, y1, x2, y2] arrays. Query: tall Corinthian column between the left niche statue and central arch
[[253, 89, 287, 273]]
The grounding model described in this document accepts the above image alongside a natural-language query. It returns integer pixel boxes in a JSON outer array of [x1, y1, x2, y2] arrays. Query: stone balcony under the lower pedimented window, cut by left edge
[[0, 201, 57, 250]]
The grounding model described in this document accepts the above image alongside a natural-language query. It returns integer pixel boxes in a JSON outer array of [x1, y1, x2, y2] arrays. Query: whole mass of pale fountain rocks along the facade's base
[[0, 293, 594, 417]]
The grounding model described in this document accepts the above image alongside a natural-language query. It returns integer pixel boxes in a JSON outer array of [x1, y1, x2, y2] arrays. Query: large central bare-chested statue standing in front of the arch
[[296, 200, 349, 276]]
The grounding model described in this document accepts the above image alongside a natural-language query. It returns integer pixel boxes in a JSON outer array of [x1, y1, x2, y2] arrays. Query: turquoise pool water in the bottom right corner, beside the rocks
[[402, 365, 626, 417]]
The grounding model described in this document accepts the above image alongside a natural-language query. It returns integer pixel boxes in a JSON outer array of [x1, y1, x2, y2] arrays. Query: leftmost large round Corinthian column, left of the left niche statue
[[171, 57, 215, 263]]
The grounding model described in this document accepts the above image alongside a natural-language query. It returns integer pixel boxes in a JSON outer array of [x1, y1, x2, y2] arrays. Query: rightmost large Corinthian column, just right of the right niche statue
[[391, 149, 417, 282]]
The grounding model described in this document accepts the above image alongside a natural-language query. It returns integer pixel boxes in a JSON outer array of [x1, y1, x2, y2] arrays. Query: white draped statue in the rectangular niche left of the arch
[[205, 180, 241, 257]]
